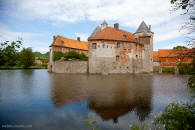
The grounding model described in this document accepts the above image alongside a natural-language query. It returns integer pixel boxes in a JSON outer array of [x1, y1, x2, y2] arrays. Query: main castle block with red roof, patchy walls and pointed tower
[[88, 21, 153, 74]]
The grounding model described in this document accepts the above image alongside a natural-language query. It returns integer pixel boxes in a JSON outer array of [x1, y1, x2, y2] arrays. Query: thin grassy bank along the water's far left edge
[[0, 66, 47, 70]]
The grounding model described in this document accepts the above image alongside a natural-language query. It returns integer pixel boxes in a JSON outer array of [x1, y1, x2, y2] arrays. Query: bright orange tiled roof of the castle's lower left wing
[[51, 35, 88, 50]]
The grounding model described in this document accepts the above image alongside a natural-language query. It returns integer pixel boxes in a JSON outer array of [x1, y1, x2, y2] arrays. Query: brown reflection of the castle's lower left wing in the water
[[51, 74, 87, 107]]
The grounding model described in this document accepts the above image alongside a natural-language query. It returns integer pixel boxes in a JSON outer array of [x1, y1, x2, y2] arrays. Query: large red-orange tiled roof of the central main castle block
[[88, 27, 137, 42]]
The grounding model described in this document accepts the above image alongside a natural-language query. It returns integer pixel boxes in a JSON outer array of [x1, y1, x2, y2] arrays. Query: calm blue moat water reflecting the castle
[[0, 70, 192, 130]]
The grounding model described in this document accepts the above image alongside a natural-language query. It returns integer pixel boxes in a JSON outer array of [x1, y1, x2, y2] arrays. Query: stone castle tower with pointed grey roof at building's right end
[[134, 21, 154, 72]]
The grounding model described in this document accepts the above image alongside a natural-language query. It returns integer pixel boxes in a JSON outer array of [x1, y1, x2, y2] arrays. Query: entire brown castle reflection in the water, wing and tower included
[[51, 75, 152, 123]]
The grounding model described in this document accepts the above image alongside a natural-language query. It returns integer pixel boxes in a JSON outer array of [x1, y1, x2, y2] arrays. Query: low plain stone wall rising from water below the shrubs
[[52, 61, 88, 74]]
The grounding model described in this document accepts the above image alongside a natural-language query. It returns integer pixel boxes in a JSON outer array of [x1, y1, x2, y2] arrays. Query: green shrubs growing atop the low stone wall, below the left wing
[[53, 51, 88, 61]]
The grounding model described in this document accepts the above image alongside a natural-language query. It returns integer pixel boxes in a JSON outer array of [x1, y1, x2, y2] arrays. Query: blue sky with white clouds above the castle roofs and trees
[[0, 0, 189, 53]]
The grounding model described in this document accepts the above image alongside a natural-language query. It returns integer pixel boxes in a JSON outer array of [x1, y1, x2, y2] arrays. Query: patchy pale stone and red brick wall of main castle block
[[89, 41, 144, 74]]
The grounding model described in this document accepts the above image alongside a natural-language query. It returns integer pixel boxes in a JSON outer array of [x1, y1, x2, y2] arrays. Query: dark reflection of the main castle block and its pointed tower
[[88, 75, 152, 123]]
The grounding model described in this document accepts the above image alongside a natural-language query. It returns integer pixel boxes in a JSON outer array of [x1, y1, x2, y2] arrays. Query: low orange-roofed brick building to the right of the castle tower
[[153, 48, 195, 72]]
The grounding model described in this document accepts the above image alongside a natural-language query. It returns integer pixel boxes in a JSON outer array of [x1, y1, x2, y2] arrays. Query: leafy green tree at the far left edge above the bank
[[0, 40, 22, 66]]
